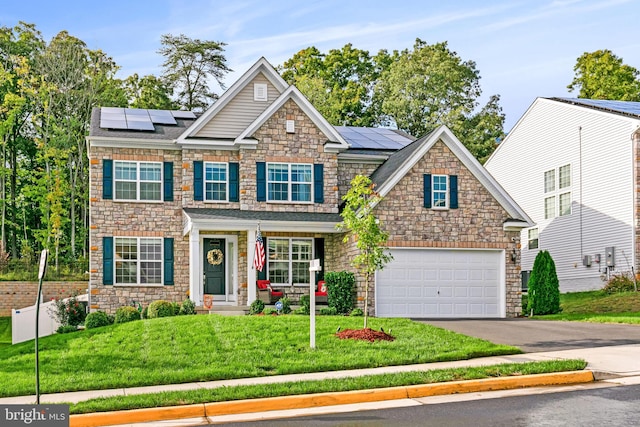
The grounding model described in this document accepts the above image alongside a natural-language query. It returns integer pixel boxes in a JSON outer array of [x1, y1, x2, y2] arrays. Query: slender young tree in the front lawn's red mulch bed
[[338, 175, 393, 328]]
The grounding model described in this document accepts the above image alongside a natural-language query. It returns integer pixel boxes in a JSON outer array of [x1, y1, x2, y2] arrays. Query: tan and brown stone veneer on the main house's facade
[[90, 100, 521, 316]]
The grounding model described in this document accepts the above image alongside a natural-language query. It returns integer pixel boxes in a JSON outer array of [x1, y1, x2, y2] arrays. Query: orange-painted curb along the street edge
[[69, 371, 594, 427]]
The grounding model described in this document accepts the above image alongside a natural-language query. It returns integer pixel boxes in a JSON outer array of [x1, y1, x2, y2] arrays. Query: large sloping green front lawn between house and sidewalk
[[0, 315, 520, 397]]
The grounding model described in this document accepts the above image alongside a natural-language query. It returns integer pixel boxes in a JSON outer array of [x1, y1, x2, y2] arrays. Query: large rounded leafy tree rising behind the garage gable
[[376, 39, 504, 159]]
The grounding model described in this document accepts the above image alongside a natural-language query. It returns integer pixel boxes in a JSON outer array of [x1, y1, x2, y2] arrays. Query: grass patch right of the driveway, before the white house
[[534, 291, 640, 324]]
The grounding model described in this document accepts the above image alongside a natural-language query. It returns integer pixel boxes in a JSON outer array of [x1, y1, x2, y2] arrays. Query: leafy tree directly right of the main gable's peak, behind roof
[[280, 43, 381, 126]]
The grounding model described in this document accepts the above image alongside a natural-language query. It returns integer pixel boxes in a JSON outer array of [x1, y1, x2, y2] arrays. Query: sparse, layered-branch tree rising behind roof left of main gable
[[158, 34, 231, 110]]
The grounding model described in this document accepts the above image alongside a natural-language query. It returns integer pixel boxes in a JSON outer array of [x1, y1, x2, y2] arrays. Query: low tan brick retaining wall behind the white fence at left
[[0, 282, 89, 317]]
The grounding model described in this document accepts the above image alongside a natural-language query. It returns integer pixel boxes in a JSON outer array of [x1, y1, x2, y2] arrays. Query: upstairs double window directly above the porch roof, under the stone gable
[[267, 163, 313, 202]]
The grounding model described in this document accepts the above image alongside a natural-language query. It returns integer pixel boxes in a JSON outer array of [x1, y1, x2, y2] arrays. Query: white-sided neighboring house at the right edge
[[485, 98, 640, 292]]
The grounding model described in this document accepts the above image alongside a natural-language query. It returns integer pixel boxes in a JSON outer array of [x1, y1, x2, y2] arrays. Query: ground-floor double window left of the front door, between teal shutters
[[115, 237, 162, 285]]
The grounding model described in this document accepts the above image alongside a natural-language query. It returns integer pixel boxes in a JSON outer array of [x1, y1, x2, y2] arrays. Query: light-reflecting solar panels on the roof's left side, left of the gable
[[100, 107, 196, 131]]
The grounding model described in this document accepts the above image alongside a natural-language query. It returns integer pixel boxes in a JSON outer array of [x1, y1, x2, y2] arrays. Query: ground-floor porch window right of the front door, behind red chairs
[[267, 237, 313, 286]]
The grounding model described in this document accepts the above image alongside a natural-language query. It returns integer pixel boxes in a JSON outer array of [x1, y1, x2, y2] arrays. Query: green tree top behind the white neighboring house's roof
[[567, 50, 640, 101]]
